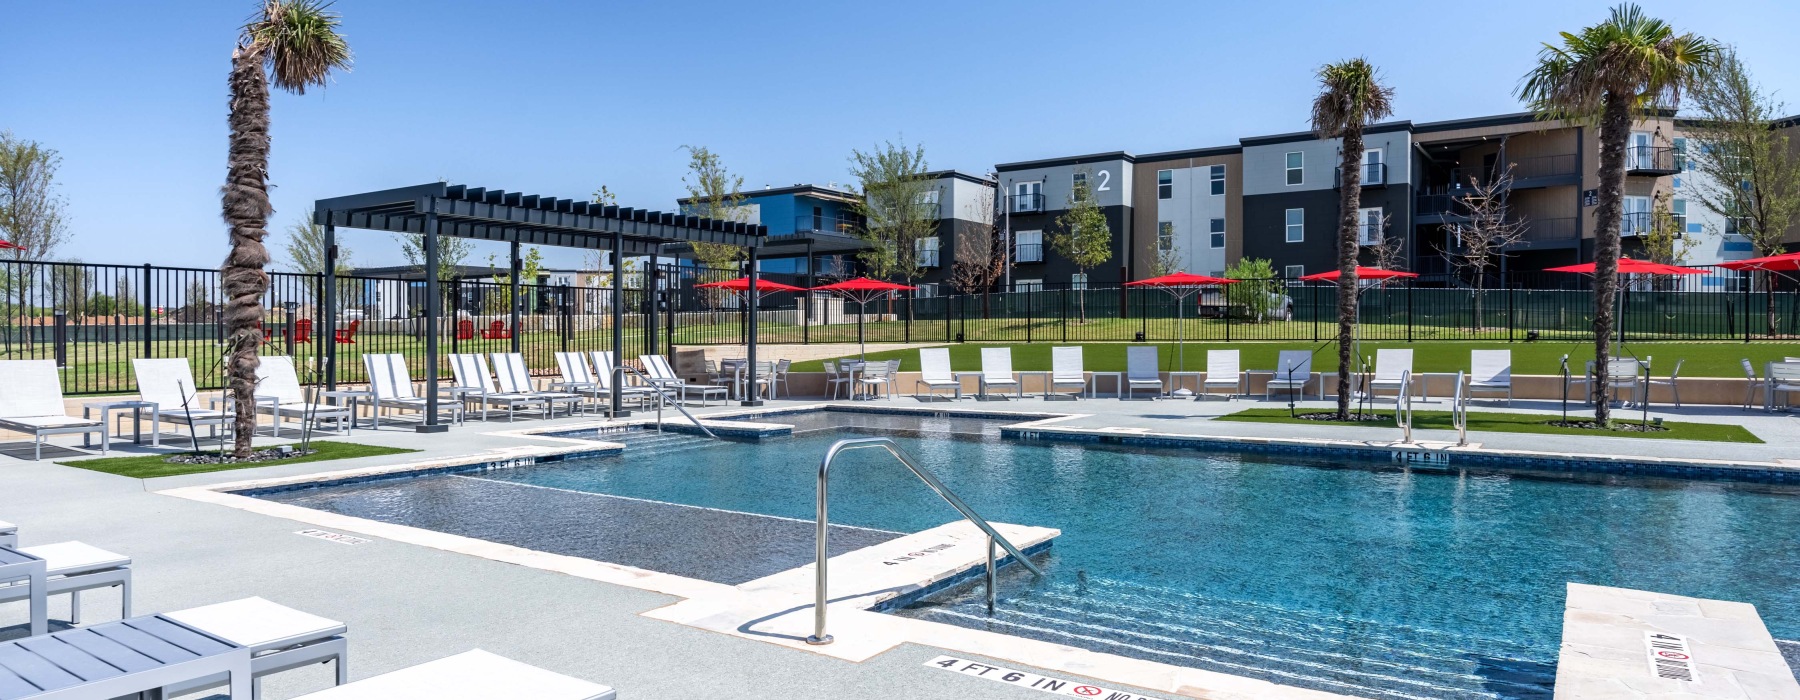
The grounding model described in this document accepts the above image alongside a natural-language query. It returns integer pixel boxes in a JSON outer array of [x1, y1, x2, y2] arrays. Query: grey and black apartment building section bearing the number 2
[[994, 151, 1136, 292]]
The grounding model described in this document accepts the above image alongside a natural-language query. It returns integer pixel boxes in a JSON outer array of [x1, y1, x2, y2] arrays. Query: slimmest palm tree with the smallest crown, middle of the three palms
[[1312, 58, 1393, 421]]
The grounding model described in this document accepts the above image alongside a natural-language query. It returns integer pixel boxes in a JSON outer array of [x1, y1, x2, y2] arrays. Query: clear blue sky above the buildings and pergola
[[0, 0, 1800, 268]]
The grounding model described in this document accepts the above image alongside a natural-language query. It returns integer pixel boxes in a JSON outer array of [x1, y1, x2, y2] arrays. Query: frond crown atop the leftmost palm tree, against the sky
[[239, 0, 351, 94]]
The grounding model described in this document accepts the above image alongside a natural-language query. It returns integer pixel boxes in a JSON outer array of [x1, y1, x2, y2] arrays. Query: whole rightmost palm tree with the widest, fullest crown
[[1519, 4, 1719, 425]]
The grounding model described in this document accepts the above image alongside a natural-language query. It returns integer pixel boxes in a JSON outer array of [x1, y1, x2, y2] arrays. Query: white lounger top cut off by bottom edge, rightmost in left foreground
[[295, 650, 617, 700]]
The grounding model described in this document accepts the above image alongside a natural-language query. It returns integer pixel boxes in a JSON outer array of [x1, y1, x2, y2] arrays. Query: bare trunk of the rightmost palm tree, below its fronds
[[1589, 94, 1631, 425]]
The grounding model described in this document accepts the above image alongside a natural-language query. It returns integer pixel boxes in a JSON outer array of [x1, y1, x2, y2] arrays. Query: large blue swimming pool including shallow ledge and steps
[[261, 412, 1800, 698]]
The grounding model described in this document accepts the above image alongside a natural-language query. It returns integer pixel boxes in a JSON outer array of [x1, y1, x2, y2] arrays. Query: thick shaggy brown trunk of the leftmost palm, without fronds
[[220, 49, 274, 457]]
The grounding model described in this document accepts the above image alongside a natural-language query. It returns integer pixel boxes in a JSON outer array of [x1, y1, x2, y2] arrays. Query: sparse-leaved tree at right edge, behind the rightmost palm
[[1687, 50, 1800, 337]]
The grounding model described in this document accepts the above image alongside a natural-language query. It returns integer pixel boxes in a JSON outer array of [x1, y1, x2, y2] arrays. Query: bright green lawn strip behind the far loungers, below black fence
[[794, 340, 1800, 378]]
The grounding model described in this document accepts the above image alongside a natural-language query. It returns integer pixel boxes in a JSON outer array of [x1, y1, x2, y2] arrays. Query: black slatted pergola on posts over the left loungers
[[313, 182, 769, 432]]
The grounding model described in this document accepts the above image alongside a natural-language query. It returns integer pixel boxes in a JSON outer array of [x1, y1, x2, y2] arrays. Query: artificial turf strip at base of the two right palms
[[1215, 408, 1762, 444]]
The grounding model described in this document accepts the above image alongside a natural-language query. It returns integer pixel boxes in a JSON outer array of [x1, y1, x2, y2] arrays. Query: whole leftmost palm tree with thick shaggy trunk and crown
[[220, 0, 349, 457]]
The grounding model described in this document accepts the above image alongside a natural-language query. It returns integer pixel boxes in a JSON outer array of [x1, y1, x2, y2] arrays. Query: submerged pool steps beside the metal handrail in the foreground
[[907, 578, 1553, 698]]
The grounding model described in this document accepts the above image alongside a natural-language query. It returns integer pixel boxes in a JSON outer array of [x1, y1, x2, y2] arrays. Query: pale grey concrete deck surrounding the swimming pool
[[0, 390, 1800, 698]]
